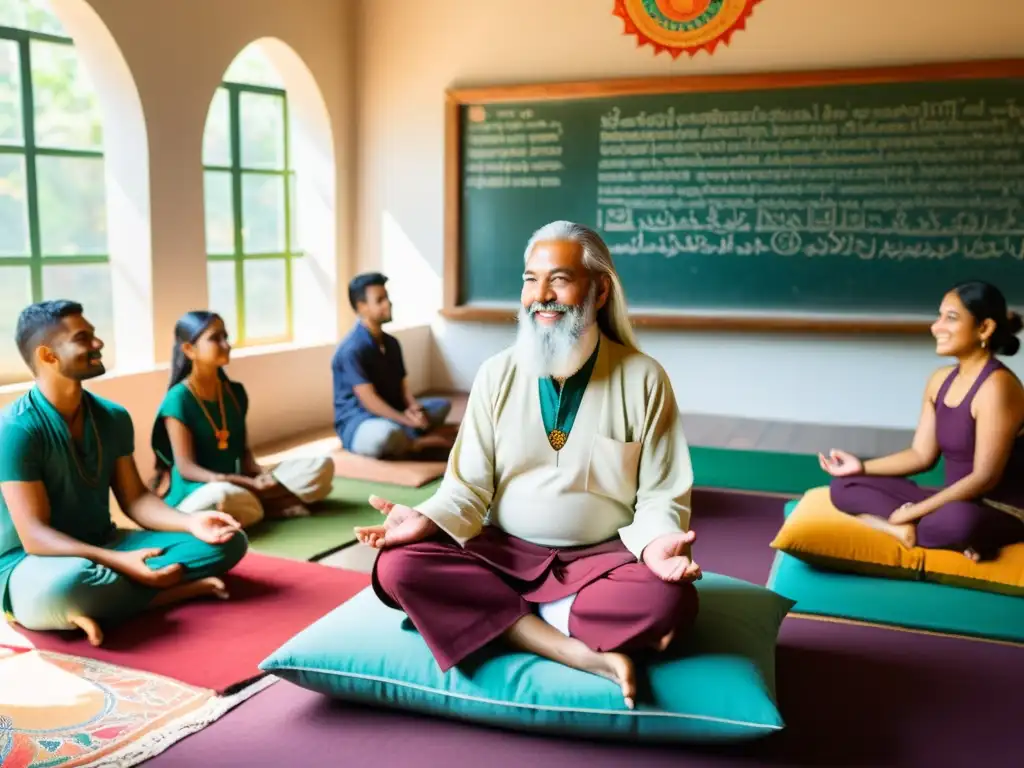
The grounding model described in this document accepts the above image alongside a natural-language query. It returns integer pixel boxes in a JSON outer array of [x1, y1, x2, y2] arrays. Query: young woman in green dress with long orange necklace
[[152, 311, 334, 527]]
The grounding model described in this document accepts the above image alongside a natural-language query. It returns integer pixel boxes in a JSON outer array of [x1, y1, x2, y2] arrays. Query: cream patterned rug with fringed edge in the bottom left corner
[[0, 647, 273, 768]]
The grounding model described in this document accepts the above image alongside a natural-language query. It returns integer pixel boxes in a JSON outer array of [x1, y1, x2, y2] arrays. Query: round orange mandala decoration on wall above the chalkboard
[[612, 0, 761, 58]]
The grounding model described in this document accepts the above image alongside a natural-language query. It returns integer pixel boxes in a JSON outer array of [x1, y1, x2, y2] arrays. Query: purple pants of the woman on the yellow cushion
[[829, 475, 1024, 560]]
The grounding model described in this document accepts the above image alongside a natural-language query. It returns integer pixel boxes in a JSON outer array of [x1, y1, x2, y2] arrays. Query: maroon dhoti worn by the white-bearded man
[[373, 526, 698, 672]]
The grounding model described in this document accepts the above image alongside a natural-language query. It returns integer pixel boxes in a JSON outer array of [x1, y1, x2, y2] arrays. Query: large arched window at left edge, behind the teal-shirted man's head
[[0, 0, 114, 383]]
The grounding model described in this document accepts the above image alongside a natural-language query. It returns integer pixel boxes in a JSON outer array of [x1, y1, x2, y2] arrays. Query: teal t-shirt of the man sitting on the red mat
[[0, 387, 135, 610]]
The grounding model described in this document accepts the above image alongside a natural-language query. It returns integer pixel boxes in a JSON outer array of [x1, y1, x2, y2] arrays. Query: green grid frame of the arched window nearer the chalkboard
[[203, 80, 303, 347]]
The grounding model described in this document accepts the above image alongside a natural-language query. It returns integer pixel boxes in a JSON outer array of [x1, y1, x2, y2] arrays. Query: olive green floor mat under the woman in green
[[248, 477, 440, 560]]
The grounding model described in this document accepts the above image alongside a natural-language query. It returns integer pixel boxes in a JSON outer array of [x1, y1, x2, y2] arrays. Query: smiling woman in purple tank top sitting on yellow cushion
[[818, 282, 1024, 561]]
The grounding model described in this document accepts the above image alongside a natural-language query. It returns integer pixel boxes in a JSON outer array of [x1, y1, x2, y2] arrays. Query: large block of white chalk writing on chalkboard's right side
[[594, 98, 1024, 260]]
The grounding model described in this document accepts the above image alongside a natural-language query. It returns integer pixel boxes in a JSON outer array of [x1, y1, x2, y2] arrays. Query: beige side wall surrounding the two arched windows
[[0, 0, 431, 481]]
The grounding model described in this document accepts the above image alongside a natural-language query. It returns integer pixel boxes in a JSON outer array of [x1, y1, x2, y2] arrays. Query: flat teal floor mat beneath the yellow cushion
[[767, 552, 1024, 643]]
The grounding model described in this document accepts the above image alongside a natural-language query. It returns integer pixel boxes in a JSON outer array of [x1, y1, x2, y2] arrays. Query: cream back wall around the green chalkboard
[[356, 0, 1024, 427]]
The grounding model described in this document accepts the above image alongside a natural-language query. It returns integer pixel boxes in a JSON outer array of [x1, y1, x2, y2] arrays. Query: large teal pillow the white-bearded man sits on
[[260, 573, 793, 742]]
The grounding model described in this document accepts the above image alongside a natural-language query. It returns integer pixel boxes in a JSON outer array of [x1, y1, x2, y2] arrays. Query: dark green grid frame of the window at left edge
[[0, 26, 111, 303]]
